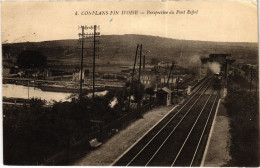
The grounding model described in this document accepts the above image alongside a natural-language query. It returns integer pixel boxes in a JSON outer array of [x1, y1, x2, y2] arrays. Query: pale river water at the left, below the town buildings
[[2, 84, 71, 101]]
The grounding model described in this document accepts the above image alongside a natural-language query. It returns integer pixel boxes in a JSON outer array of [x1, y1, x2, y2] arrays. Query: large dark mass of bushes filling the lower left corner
[[3, 92, 129, 165]]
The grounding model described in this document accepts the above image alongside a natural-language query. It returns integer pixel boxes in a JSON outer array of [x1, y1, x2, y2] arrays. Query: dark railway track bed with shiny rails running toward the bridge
[[112, 78, 219, 166]]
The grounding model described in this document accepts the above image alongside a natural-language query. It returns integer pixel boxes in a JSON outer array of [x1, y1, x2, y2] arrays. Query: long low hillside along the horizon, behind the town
[[3, 35, 258, 68]]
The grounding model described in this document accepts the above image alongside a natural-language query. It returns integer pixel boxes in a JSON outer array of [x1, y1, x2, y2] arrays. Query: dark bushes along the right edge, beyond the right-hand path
[[225, 86, 259, 166]]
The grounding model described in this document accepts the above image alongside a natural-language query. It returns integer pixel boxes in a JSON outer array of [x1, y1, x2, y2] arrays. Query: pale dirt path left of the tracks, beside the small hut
[[73, 105, 178, 166]]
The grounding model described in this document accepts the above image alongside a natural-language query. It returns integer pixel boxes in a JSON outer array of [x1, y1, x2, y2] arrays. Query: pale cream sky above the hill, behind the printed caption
[[1, 1, 258, 43]]
